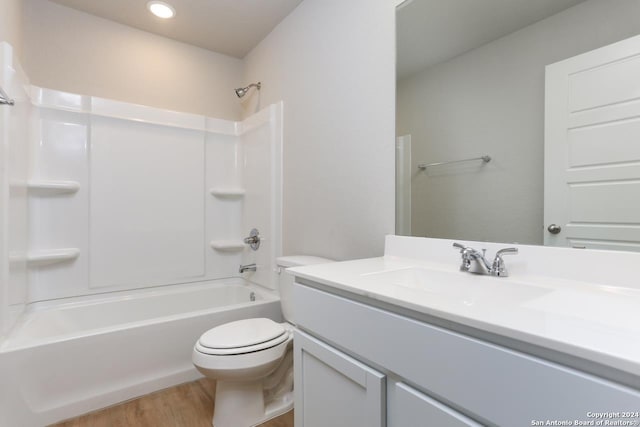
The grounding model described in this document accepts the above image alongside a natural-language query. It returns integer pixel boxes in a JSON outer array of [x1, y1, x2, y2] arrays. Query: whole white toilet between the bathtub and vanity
[[192, 256, 332, 427]]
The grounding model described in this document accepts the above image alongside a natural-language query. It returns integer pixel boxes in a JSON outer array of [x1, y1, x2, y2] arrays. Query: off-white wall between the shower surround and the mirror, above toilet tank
[[244, 0, 397, 259]]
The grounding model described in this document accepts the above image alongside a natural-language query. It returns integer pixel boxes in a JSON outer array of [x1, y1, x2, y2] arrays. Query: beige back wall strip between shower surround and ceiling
[[21, 0, 243, 120]]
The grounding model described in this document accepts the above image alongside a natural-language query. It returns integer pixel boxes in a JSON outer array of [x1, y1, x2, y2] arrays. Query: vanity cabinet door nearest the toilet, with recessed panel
[[293, 331, 385, 427]]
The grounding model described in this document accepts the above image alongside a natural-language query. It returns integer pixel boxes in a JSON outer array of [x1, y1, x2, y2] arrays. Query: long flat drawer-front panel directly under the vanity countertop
[[294, 284, 640, 426]]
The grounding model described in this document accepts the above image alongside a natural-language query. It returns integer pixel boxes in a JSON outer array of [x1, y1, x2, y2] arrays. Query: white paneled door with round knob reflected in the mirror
[[544, 36, 640, 251]]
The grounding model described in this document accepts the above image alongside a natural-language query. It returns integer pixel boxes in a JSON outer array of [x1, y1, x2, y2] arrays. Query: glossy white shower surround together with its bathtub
[[0, 43, 282, 425]]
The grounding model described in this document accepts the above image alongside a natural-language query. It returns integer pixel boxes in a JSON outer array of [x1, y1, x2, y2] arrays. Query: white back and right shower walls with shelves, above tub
[[29, 88, 282, 301]]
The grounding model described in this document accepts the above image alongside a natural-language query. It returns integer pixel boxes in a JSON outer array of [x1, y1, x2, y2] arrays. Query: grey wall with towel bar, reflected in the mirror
[[397, 0, 640, 244]]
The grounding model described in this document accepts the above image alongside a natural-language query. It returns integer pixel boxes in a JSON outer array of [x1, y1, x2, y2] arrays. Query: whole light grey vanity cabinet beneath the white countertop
[[294, 280, 640, 427]]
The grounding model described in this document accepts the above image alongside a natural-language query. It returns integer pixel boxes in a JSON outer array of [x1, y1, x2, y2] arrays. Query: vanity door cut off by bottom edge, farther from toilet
[[389, 383, 480, 427]]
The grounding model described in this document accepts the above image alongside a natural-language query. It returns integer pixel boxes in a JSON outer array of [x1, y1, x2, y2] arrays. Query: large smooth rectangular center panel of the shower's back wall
[[89, 117, 205, 287]]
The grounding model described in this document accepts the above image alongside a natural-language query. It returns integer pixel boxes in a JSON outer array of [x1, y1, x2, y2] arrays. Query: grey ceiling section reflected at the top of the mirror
[[396, 0, 584, 79]]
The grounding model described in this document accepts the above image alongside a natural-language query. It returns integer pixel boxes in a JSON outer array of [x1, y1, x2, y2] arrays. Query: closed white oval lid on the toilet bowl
[[199, 318, 285, 350]]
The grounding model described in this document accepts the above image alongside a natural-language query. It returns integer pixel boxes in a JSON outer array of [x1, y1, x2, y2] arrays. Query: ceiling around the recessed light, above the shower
[[51, 0, 302, 58]]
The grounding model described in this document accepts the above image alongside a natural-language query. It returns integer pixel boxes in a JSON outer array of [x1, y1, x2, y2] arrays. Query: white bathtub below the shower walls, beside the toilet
[[0, 279, 281, 427]]
